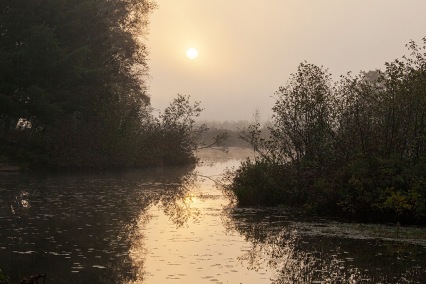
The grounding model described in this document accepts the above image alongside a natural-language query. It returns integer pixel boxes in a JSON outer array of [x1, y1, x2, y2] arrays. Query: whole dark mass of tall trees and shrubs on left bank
[[0, 0, 223, 169]]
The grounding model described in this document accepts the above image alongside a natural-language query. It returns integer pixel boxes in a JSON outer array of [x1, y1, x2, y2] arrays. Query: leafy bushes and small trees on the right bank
[[226, 38, 426, 224]]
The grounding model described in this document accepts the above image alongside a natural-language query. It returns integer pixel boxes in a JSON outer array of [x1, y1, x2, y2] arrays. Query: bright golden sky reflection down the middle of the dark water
[[129, 156, 272, 284]]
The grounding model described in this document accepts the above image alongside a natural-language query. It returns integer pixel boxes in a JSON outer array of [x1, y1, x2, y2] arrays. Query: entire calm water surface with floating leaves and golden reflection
[[0, 150, 426, 283]]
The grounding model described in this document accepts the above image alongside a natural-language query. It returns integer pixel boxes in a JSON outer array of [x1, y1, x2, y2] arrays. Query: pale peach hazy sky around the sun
[[148, 0, 426, 120]]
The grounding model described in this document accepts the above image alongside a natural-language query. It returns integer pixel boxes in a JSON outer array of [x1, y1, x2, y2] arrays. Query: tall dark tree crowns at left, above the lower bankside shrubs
[[0, 0, 154, 127]]
